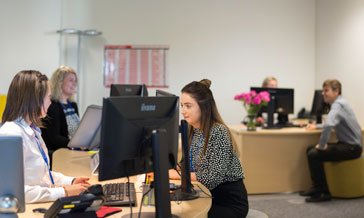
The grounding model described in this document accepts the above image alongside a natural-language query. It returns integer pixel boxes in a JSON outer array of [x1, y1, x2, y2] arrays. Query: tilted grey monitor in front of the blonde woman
[[67, 105, 102, 150]]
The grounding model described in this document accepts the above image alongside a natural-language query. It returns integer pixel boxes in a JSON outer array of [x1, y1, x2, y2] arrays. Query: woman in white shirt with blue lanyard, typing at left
[[0, 70, 90, 203]]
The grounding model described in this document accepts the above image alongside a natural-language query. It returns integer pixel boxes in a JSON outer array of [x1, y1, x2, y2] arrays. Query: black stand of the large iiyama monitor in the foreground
[[123, 130, 179, 218]]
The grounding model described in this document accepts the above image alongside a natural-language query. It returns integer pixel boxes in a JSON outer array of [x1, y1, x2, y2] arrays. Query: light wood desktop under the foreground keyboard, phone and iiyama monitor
[[18, 148, 211, 218]]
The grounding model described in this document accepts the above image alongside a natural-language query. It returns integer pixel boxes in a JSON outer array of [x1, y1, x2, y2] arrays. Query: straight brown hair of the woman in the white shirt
[[2, 70, 48, 127]]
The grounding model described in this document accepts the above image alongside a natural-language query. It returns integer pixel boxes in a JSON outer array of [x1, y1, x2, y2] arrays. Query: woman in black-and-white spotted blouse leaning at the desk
[[170, 79, 249, 218]]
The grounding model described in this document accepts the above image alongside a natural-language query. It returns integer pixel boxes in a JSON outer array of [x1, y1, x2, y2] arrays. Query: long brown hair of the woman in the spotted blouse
[[181, 79, 238, 155]]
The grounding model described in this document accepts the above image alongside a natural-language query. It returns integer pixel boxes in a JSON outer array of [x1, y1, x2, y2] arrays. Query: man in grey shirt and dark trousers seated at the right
[[300, 80, 362, 202]]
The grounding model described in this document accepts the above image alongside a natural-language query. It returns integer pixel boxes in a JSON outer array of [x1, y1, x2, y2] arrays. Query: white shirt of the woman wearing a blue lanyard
[[0, 118, 74, 203]]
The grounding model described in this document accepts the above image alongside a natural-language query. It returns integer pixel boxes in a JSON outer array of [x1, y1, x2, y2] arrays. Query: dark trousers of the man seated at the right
[[307, 142, 362, 193]]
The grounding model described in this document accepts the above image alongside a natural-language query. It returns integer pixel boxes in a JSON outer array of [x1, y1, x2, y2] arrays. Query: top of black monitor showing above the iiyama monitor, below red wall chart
[[110, 84, 148, 96]]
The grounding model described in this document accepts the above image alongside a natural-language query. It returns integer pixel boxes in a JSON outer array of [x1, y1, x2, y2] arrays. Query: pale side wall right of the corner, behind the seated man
[[316, 0, 364, 127]]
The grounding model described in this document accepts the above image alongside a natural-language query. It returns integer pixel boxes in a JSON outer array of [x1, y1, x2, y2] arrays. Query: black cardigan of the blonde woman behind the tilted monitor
[[42, 101, 78, 151]]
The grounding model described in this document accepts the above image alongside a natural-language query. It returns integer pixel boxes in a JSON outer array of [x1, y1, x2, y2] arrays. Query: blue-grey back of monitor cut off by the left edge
[[0, 136, 25, 217]]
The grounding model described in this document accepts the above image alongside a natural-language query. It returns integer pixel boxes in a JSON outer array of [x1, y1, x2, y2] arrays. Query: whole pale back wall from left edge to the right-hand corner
[[0, 0, 315, 124]]
